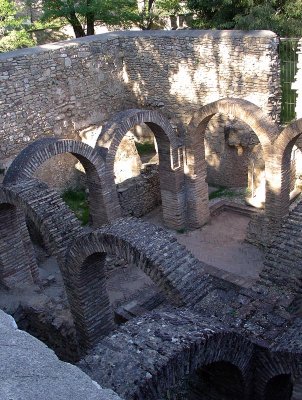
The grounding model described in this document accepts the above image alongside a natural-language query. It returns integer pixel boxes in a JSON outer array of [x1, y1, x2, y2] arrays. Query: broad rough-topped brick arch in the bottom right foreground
[[80, 309, 301, 400]]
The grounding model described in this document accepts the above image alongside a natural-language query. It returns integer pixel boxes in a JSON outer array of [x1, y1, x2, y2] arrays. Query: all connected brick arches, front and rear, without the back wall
[[0, 99, 302, 400]]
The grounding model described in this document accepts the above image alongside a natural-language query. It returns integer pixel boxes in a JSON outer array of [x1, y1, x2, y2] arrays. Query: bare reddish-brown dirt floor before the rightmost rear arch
[[144, 208, 263, 280]]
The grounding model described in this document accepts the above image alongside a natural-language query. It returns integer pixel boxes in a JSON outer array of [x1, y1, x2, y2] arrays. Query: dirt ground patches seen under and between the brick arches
[[0, 203, 263, 362]]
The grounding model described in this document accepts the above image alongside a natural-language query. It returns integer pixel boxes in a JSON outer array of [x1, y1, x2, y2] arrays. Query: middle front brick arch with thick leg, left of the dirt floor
[[66, 218, 211, 349]]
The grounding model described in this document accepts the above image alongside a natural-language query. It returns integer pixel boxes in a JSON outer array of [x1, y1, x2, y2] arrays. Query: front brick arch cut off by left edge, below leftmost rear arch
[[0, 179, 82, 287]]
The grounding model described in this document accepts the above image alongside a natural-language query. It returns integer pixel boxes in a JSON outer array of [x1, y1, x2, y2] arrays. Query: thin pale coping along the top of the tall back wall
[[0, 29, 277, 61]]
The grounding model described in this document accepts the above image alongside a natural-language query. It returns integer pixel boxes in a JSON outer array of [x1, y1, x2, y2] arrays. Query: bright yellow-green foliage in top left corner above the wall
[[0, 0, 35, 52]]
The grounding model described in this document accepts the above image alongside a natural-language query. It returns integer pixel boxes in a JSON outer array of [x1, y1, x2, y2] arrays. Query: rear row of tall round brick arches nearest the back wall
[[4, 98, 302, 234]]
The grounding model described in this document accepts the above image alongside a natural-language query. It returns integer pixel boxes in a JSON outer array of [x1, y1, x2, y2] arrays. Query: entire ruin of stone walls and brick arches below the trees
[[0, 30, 302, 400]]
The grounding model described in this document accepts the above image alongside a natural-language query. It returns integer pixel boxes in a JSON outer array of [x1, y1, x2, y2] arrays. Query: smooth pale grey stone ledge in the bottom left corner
[[0, 310, 121, 400]]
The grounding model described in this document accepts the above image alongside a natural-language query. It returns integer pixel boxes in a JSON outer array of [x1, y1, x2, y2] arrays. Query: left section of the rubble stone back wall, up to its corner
[[0, 37, 124, 186]]
